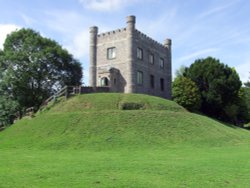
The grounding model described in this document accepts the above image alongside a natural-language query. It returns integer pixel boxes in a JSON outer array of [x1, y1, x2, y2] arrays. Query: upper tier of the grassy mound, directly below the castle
[[46, 93, 185, 112]]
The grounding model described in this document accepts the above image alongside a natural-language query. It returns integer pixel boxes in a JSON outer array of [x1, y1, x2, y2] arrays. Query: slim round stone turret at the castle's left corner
[[89, 26, 98, 87]]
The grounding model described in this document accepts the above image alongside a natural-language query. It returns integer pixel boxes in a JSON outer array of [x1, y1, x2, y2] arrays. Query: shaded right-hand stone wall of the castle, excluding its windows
[[133, 30, 172, 98]]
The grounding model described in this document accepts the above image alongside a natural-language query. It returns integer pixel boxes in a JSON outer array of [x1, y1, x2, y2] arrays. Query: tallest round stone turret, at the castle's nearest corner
[[125, 16, 136, 93]]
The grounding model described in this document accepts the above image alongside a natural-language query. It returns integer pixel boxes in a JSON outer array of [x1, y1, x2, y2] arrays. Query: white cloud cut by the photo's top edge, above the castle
[[79, 0, 140, 11]]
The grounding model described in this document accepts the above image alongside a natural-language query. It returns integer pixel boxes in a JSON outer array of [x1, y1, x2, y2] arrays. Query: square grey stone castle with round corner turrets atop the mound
[[89, 16, 172, 99]]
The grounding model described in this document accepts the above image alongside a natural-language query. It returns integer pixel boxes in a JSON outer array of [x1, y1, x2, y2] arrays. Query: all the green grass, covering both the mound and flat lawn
[[0, 94, 250, 188]]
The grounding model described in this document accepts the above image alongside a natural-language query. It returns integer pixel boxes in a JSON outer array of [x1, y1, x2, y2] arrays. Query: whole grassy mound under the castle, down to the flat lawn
[[0, 94, 249, 150]]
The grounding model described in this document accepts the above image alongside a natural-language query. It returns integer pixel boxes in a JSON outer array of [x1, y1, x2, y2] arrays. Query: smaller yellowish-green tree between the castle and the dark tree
[[172, 76, 201, 111]]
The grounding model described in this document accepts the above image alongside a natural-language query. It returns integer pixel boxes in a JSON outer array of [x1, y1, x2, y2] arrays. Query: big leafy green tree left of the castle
[[0, 29, 82, 112]]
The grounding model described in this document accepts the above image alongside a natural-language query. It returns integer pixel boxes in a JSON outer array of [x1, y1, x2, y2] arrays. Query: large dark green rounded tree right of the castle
[[184, 57, 241, 120]]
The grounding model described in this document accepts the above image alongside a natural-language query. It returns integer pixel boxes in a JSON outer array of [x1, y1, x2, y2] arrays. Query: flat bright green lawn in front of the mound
[[0, 145, 250, 188]]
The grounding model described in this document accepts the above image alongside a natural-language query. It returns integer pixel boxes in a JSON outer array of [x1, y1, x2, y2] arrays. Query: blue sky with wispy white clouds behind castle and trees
[[0, 0, 250, 85]]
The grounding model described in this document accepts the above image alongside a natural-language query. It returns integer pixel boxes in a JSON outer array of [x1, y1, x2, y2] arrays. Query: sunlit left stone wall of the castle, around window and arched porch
[[96, 28, 129, 92]]
